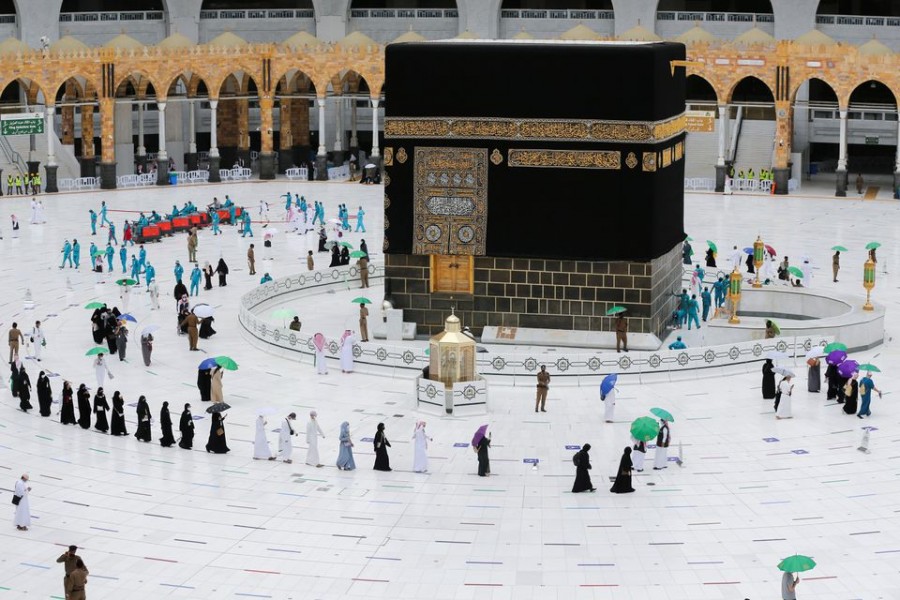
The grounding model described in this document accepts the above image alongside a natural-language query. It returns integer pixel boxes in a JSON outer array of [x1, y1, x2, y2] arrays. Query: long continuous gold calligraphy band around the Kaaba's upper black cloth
[[384, 114, 686, 144]]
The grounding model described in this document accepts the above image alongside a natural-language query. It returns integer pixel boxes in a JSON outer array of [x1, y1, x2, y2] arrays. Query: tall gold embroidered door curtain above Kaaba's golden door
[[413, 147, 488, 256]]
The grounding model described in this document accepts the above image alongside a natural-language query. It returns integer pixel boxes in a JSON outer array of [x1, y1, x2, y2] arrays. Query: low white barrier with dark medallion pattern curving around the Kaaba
[[238, 264, 834, 385]]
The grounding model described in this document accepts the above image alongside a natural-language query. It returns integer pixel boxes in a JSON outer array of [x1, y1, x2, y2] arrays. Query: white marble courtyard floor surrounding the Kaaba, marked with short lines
[[0, 181, 900, 600]]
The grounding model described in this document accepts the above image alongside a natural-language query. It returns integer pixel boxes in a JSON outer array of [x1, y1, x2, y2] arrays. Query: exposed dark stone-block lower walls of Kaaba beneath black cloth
[[385, 245, 682, 335]]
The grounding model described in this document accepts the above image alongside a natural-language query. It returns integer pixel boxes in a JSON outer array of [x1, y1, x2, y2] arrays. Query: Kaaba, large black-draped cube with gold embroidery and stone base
[[384, 40, 685, 335]]
